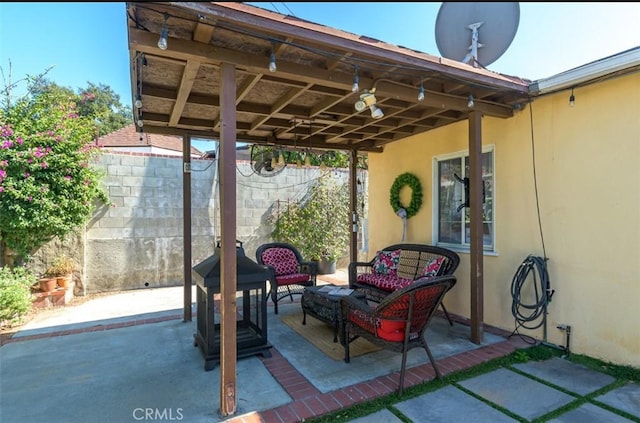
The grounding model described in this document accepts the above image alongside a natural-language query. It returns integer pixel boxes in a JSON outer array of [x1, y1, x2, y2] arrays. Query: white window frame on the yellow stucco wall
[[431, 144, 496, 254]]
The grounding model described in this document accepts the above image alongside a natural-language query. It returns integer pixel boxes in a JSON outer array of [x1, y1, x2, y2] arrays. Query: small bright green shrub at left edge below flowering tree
[[0, 266, 38, 324]]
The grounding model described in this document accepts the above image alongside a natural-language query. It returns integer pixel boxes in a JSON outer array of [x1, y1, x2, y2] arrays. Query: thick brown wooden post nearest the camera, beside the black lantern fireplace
[[220, 63, 238, 417]]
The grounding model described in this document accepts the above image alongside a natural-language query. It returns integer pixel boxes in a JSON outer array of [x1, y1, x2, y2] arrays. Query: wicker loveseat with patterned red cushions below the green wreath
[[349, 244, 460, 324]]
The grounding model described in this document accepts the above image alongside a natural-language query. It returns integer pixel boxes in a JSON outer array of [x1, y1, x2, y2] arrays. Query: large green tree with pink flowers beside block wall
[[0, 79, 108, 262]]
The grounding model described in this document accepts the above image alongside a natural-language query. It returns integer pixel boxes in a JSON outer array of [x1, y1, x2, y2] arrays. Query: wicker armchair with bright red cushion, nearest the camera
[[340, 275, 456, 395]]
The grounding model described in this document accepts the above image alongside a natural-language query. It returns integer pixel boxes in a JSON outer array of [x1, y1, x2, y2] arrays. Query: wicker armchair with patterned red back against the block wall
[[256, 242, 318, 314]]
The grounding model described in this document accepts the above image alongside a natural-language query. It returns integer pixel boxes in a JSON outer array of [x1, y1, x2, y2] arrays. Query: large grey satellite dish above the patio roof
[[436, 2, 520, 67]]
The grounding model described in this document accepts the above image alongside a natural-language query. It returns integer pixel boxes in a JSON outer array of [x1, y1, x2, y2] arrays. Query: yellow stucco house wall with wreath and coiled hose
[[368, 73, 640, 367]]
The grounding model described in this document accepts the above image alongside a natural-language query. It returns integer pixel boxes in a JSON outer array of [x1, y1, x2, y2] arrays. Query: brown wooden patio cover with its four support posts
[[126, 2, 530, 415]]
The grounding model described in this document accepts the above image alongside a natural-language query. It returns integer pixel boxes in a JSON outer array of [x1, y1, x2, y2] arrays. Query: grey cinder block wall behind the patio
[[83, 152, 358, 294]]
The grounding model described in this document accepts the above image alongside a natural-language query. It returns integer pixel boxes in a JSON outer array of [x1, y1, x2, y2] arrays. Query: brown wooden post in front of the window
[[469, 111, 484, 344]]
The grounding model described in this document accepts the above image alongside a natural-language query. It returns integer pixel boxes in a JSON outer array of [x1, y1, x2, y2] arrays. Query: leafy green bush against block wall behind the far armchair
[[272, 177, 350, 274]]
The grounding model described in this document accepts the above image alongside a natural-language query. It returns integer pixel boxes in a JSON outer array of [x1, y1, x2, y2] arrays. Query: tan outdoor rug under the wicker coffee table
[[280, 311, 380, 361]]
